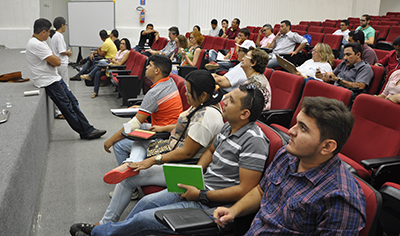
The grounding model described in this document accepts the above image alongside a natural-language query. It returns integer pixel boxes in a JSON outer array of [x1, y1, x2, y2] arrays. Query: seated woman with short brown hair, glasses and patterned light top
[[241, 47, 271, 111]]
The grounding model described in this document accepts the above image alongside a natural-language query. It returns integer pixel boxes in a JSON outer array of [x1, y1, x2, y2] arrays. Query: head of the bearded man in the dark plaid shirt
[[286, 97, 354, 161]]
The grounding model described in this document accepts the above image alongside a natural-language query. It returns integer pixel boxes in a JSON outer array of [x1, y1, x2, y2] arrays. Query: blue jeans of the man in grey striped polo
[[91, 189, 209, 236]]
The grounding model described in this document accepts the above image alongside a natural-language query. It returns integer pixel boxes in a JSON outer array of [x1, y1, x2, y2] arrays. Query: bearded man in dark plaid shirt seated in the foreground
[[214, 97, 366, 235]]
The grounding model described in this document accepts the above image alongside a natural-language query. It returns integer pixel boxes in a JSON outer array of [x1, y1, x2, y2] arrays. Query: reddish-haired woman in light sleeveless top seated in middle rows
[[179, 30, 204, 66]]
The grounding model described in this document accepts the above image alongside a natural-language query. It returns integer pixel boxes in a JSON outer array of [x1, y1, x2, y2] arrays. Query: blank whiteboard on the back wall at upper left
[[67, 1, 115, 47]]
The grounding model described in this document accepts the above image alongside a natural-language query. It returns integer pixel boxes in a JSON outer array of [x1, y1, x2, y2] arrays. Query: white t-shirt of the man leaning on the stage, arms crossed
[[26, 37, 61, 88]]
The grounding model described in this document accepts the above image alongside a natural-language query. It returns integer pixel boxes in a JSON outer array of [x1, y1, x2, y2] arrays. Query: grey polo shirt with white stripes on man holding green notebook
[[204, 122, 269, 190]]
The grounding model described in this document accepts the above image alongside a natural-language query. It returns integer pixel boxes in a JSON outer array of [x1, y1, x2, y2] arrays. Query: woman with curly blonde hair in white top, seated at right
[[293, 43, 335, 81]]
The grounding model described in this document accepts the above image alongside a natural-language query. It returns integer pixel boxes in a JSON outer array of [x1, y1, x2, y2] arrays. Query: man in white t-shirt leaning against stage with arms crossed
[[26, 18, 106, 139]]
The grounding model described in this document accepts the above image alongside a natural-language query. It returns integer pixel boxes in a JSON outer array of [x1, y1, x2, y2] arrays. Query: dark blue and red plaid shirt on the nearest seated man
[[246, 147, 366, 235]]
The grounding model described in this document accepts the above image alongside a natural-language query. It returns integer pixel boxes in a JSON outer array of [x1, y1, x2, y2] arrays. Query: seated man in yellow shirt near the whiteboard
[[71, 29, 118, 80]]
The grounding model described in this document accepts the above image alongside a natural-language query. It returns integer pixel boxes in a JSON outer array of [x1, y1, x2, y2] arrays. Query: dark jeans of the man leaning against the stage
[[45, 79, 94, 138]]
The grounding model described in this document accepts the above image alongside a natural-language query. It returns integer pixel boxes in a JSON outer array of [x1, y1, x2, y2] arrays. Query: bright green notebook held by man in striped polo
[[163, 163, 204, 193]]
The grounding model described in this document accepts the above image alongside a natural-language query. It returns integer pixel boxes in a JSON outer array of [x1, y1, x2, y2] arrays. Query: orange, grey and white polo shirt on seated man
[[138, 77, 183, 126]]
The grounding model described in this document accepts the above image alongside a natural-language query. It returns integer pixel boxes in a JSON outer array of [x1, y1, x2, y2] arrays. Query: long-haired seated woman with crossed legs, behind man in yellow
[[81, 38, 131, 98]]
